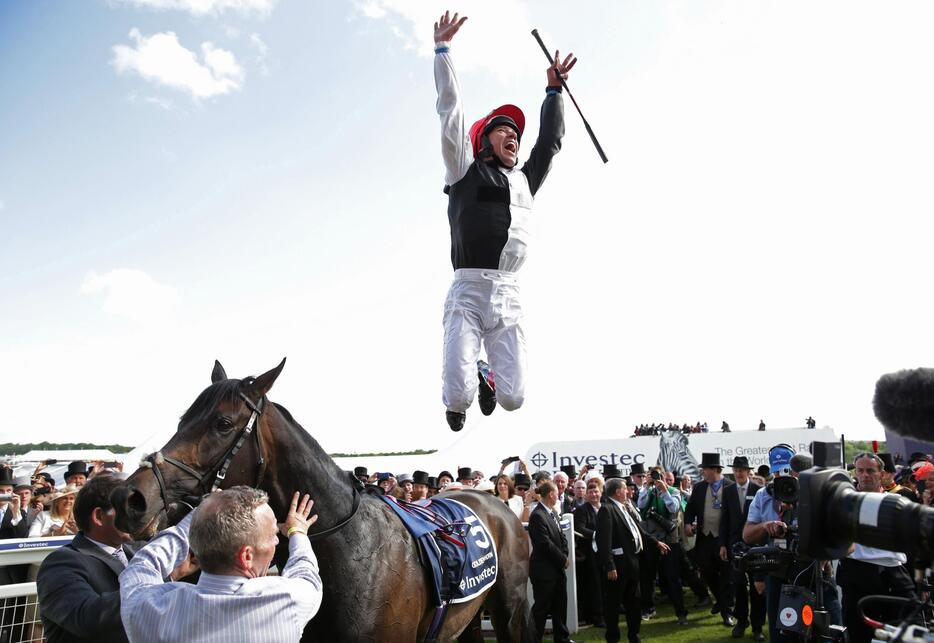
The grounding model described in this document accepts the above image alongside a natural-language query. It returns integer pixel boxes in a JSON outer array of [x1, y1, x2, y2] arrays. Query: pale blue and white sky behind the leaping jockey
[[0, 0, 934, 451]]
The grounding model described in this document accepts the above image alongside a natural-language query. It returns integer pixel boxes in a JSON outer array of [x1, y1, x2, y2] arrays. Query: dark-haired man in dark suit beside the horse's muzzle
[[36, 474, 140, 643]]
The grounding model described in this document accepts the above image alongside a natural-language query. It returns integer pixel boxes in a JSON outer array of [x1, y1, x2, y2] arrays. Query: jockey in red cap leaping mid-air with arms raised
[[435, 12, 577, 431]]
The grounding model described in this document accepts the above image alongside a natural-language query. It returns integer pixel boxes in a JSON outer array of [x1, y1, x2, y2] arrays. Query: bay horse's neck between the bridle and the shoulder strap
[[264, 407, 353, 532]]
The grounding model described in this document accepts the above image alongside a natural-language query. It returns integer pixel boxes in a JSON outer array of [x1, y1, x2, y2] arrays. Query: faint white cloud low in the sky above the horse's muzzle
[[81, 268, 178, 326]]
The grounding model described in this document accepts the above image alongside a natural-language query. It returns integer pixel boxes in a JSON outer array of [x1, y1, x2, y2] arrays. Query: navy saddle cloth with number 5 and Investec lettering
[[380, 496, 499, 606]]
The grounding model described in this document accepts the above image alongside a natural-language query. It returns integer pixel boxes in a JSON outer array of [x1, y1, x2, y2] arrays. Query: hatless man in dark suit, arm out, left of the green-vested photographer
[[596, 478, 669, 643]]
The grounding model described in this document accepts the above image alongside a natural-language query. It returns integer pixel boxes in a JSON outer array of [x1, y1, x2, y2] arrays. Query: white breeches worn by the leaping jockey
[[441, 268, 526, 412]]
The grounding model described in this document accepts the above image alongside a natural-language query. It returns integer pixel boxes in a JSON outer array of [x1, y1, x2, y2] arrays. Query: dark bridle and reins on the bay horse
[[140, 392, 360, 538]]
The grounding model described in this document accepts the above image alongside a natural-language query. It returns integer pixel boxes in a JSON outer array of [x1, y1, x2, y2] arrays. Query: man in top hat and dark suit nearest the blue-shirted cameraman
[[720, 456, 765, 641]]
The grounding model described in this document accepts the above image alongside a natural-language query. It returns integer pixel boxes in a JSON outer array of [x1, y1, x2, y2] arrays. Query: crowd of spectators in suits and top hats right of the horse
[[355, 448, 934, 643]]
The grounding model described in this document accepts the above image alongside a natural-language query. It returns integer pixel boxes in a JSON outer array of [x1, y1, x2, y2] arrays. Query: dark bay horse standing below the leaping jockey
[[112, 359, 531, 643]]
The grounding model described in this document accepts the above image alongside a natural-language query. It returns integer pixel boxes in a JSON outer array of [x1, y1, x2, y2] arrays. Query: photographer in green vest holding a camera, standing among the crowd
[[637, 466, 688, 625]]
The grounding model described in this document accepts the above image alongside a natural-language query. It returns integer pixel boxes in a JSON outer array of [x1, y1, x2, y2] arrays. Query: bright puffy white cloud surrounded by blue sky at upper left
[[111, 28, 244, 99]]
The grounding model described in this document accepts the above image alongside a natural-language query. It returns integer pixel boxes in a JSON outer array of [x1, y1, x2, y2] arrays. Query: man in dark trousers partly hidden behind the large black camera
[[837, 453, 920, 643]]
